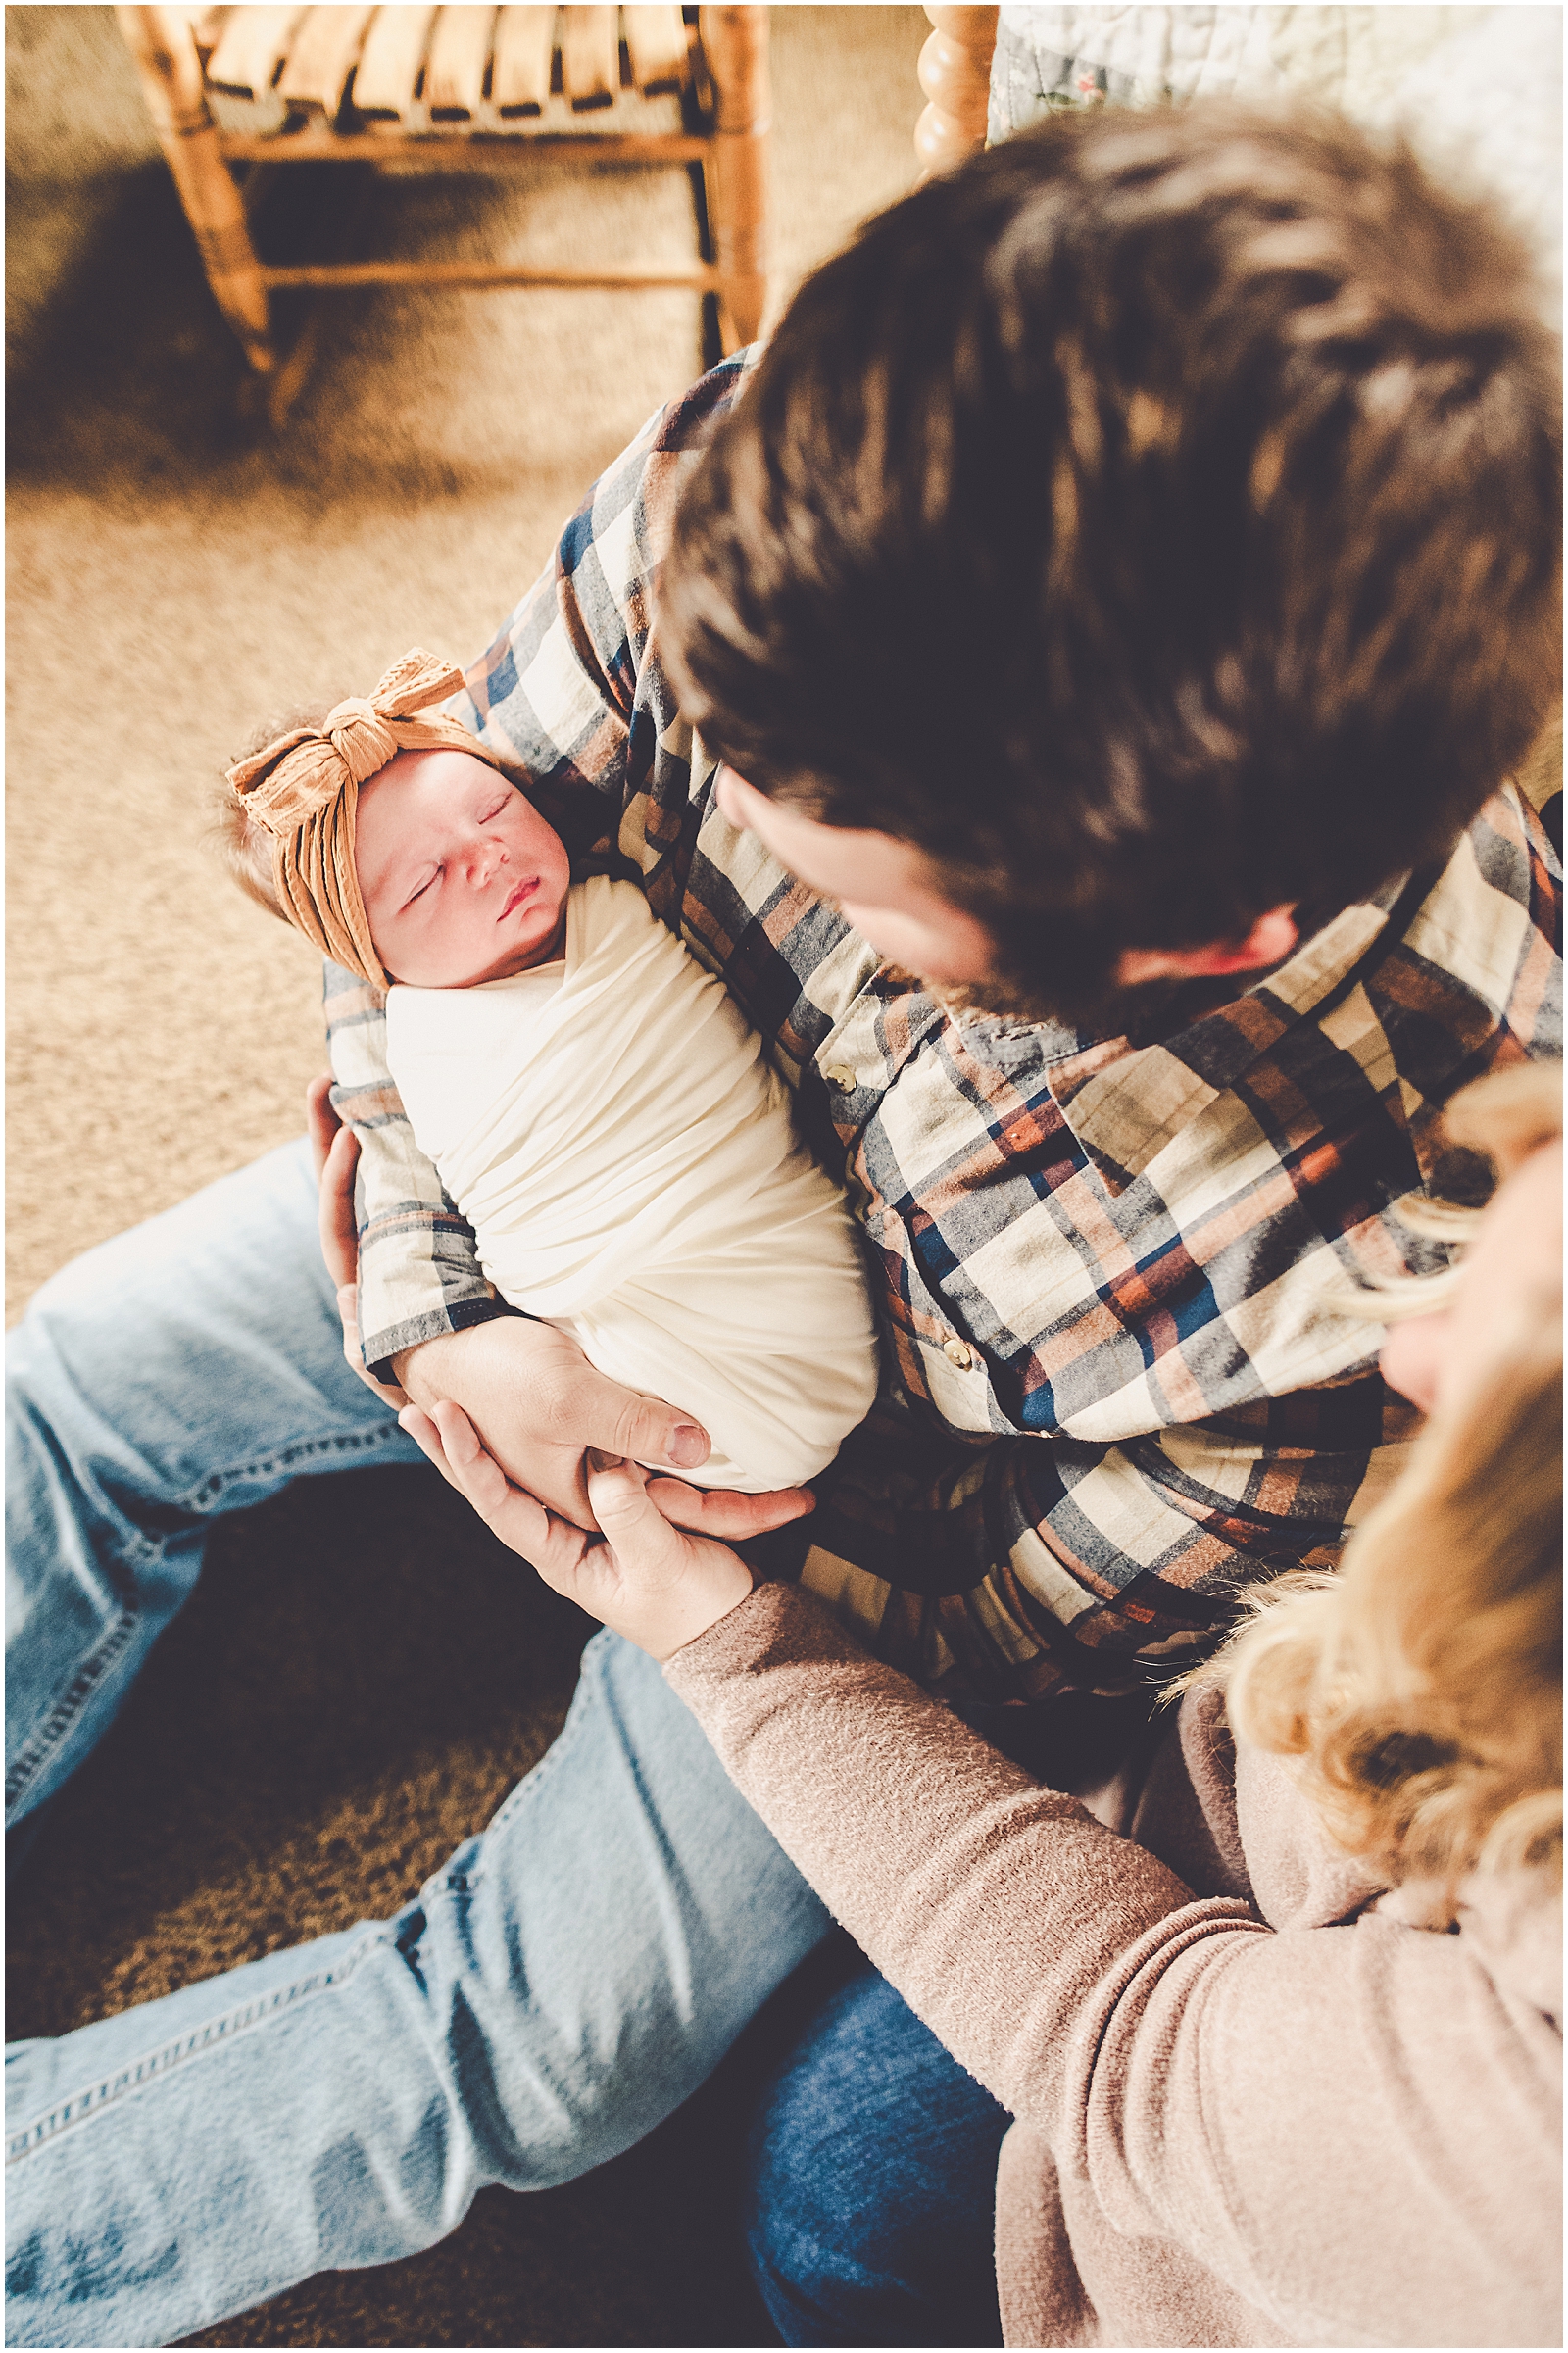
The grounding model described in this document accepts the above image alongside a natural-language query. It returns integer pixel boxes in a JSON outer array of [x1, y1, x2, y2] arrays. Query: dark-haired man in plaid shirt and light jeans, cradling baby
[[10, 108, 1561, 2343]]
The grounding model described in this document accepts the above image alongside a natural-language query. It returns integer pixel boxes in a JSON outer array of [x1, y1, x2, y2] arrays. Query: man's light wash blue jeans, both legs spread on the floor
[[5, 1144, 829, 2346]]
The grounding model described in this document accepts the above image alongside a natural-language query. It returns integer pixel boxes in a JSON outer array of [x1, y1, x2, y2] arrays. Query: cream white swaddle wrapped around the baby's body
[[386, 878, 876, 1490]]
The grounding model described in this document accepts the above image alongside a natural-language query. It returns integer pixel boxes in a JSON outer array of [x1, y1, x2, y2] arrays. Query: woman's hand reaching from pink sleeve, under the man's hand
[[398, 1404, 751, 1659]]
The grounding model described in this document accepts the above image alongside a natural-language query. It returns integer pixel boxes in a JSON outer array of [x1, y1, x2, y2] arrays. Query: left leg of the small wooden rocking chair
[[116, 7, 277, 376]]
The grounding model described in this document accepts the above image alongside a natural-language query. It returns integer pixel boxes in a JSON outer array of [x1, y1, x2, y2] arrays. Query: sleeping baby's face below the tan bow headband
[[356, 751, 572, 988]]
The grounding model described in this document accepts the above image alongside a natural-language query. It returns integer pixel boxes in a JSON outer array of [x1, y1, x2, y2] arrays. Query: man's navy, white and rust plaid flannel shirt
[[327, 363, 1561, 1701]]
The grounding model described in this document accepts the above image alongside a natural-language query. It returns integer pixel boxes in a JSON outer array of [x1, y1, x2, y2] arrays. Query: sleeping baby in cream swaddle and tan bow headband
[[223, 652, 876, 1492]]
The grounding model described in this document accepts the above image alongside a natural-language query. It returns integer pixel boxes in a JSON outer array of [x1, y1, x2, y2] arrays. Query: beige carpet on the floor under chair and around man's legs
[[5, 7, 928, 2346]]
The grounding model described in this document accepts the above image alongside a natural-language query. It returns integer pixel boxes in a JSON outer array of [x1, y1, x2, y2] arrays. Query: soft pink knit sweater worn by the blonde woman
[[666, 1586, 1561, 2346]]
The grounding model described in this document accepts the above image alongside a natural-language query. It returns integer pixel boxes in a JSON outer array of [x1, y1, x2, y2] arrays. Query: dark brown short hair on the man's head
[[660, 104, 1561, 1007]]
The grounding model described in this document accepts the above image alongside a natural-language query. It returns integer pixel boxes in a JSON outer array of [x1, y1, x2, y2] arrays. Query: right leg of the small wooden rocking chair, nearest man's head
[[697, 7, 772, 351]]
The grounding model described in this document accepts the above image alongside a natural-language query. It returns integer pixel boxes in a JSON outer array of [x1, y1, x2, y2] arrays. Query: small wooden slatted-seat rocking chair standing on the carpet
[[116, 5, 770, 423]]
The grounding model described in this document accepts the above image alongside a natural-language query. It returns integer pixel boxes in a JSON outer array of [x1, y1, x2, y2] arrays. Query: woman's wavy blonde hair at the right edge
[[1184, 1066, 1563, 1918]]
